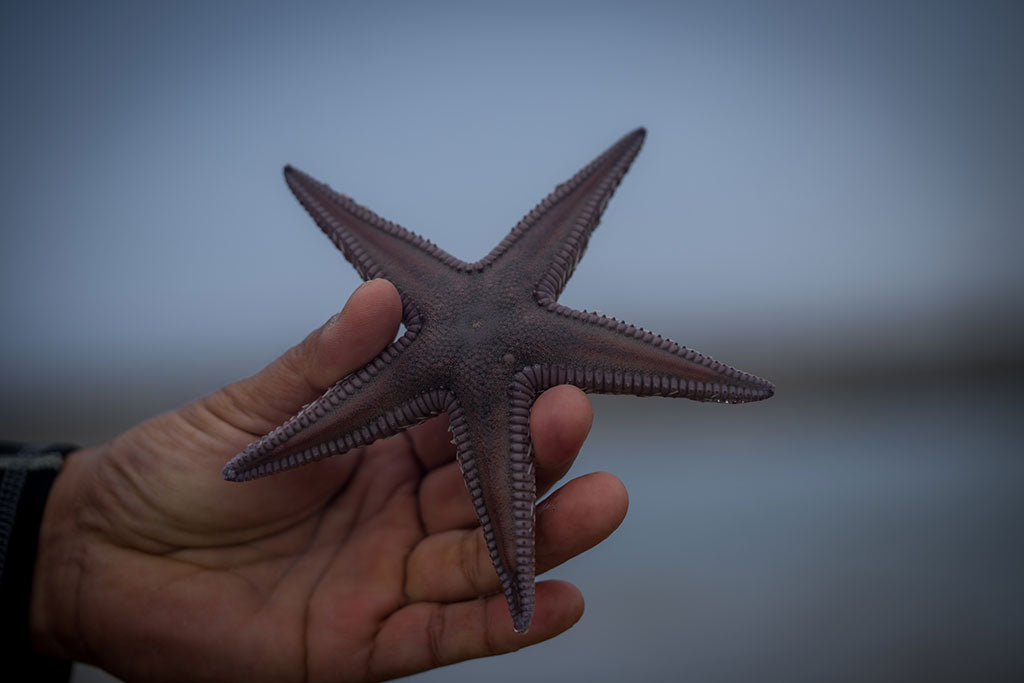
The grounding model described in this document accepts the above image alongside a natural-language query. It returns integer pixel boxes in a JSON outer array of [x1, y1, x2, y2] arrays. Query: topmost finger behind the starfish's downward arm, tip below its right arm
[[420, 385, 594, 533]]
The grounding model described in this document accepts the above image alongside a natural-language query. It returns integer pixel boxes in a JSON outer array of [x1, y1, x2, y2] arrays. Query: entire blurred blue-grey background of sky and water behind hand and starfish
[[0, 0, 1024, 683]]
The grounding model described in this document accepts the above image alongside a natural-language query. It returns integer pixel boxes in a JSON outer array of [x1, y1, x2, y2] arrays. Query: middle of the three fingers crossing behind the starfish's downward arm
[[406, 472, 629, 602]]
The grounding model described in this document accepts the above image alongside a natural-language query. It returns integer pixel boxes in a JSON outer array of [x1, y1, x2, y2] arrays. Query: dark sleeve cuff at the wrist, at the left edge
[[0, 441, 77, 681]]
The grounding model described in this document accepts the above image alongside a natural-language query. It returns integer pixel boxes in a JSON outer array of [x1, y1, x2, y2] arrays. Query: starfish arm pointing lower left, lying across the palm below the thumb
[[223, 335, 450, 481]]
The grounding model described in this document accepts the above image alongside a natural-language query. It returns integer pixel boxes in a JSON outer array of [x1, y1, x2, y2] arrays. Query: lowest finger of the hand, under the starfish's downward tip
[[369, 581, 584, 679]]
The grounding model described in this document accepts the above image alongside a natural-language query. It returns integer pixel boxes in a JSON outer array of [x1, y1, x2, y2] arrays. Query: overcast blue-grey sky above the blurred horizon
[[0, 2, 1024, 389]]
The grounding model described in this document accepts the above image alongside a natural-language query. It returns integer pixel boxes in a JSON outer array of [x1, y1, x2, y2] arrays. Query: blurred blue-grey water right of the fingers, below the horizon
[[66, 382, 1024, 683]]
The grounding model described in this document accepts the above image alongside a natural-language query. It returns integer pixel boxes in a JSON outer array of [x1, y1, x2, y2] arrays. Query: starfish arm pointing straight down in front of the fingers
[[447, 386, 537, 633]]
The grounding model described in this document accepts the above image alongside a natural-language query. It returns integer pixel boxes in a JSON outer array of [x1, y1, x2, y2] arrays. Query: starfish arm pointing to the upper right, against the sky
[[474, 128, 646, 292]]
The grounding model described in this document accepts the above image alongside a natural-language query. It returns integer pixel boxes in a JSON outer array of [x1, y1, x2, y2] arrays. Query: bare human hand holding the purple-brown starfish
[[32, 281, 627, 681]]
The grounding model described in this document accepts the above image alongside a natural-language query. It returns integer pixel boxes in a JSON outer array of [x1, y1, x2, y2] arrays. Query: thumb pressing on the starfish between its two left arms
[[202, 280, 401, 435]]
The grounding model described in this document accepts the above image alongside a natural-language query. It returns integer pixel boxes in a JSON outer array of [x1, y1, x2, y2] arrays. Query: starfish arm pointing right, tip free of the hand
[[523, 302, 775, 403]]
